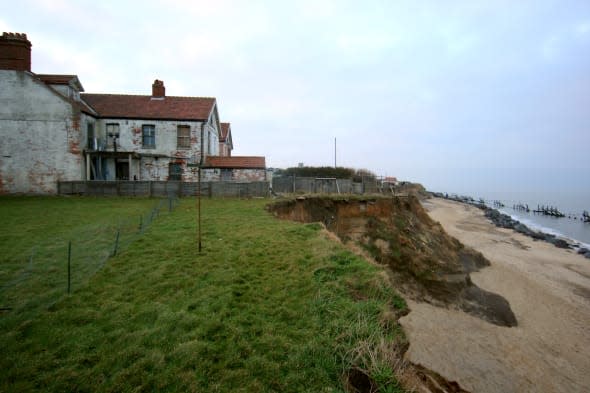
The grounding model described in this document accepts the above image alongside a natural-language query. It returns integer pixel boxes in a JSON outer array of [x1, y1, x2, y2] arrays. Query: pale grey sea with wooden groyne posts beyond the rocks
[[449, 191, 590, 249]]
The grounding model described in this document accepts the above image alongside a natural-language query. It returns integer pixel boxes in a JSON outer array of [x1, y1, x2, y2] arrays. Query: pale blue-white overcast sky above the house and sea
[[0, 0, 590, 192]]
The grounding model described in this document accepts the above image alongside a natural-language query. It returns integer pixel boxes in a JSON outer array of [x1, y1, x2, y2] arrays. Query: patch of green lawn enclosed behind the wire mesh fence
[[0, 197, 176, 327]]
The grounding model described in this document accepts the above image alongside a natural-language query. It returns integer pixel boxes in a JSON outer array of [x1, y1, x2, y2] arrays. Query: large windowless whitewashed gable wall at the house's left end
[[0, 70, 86, 194]]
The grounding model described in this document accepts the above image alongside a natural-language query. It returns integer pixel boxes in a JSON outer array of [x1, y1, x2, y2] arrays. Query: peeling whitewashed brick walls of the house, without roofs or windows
[[0, 70, 227, 194]]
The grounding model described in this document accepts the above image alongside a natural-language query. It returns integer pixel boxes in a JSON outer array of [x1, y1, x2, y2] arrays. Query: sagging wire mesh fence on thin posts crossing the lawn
[[0, 197, 180, 325]]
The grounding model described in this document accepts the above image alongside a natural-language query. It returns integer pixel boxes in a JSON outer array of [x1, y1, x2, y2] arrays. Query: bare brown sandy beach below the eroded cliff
[[400, 199, 590, 393]]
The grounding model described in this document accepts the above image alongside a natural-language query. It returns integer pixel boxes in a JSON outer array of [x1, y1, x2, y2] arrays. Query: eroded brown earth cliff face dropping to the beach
[[268, 196, 517, 326]]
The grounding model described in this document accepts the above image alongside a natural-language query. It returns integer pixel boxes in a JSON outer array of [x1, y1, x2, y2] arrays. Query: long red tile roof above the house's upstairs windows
[[81, 94, 215, 120]]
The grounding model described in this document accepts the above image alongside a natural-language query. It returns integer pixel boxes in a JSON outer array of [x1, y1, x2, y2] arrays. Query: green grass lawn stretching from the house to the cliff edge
[[0, 198, 405, 392]]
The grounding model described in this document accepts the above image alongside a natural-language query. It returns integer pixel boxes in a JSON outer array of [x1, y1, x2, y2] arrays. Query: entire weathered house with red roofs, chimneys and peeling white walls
[[0, 33, 266, 194]]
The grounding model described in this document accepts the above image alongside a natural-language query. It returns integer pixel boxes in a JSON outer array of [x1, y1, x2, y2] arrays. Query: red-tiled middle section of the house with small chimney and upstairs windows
[[81, 80, 220, 181]]
